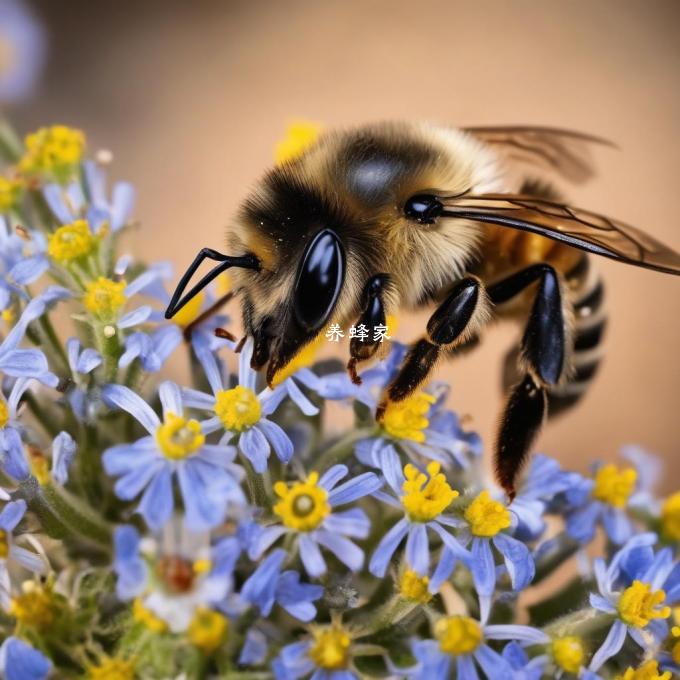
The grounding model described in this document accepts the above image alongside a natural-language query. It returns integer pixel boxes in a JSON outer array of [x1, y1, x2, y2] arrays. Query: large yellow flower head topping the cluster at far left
[[19, 125, 85, 183]]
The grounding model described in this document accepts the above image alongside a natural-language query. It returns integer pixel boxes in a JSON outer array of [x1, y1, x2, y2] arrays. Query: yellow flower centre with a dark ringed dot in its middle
[[274, 472, 331, 531]]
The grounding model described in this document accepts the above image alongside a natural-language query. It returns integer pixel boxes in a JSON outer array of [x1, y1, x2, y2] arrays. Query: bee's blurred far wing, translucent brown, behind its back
[[461, 126, 616, 184]]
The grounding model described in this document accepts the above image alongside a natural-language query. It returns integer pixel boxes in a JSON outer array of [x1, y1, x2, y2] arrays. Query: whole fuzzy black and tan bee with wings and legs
[[166, 123, 680, 499]]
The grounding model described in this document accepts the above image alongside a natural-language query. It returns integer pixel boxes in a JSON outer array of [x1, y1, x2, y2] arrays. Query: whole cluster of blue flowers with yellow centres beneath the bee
[[0, 114, 680, 680]]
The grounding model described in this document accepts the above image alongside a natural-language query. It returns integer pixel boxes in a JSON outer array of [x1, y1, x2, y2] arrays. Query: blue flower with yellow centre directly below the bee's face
[[184, 338, 293, 473]]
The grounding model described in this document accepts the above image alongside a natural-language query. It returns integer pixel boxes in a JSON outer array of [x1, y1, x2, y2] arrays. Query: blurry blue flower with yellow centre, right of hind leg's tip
[[565, 454, 638, 545]]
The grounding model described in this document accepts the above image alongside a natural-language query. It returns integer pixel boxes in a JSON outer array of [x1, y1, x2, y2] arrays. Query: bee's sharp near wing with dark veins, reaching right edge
[[442, 194, 680, 274]]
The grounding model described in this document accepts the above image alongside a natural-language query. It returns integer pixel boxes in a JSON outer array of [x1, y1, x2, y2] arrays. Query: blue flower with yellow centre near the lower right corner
[[589, 533, 680, 671]]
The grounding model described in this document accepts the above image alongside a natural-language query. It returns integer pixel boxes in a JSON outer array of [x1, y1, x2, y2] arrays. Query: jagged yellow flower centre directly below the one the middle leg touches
[[400, 461, 458, 522]]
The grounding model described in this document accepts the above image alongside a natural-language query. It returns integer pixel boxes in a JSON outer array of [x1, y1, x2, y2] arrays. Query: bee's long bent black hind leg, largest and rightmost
[[488, 264, 570, 500]]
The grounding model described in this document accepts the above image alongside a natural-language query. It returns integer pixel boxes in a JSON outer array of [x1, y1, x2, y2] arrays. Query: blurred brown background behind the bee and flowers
[[14, 0, 680, 490]]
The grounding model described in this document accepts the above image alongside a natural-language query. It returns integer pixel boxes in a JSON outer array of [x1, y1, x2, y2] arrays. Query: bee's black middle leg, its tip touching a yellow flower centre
[[376, 276, 489, 420]]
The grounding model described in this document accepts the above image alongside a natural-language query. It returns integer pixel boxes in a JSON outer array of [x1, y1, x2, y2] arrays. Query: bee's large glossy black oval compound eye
[[293, 229, 345, 332]]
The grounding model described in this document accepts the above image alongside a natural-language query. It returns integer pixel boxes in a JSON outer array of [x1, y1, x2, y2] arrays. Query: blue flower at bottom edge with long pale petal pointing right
[[406, 616, 549, 680]]
